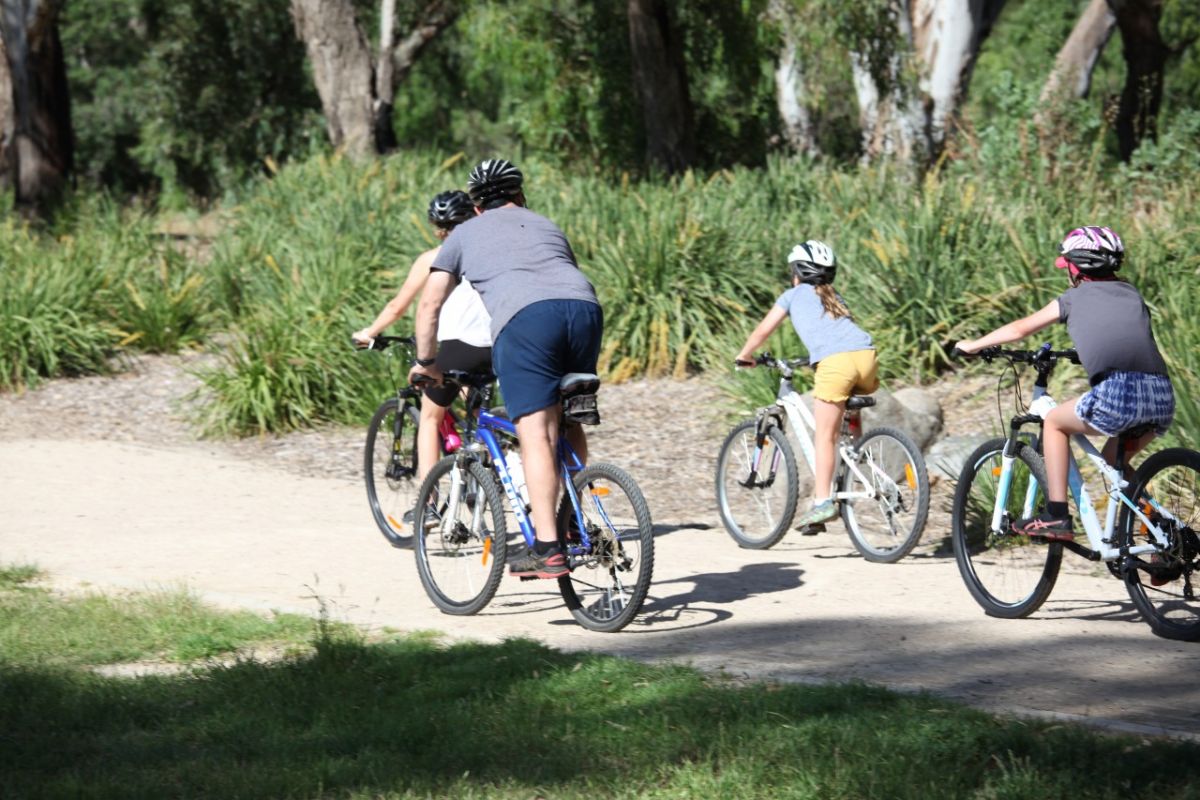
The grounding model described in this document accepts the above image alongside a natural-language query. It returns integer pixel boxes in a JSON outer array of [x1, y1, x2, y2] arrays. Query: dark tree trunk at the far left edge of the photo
[[0, 0, 74, 213]]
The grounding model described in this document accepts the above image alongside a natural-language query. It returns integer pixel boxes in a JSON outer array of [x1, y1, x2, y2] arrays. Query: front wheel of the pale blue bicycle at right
[[950, 439, 1062, 619]]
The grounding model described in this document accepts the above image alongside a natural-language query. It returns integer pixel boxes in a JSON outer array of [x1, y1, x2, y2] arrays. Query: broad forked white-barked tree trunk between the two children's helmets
[[851, 0, 1006, 163]]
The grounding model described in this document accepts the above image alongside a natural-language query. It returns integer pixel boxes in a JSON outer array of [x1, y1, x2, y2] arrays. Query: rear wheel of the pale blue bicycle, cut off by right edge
[[1118, 447, 1200, 642]]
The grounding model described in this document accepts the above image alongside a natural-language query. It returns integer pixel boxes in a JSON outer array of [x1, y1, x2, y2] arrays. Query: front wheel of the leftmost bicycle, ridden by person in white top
[[362, 397, 421, 547]]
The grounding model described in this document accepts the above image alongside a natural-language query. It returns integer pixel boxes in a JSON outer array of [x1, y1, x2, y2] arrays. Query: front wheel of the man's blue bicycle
[[415, 456, 508, 615]]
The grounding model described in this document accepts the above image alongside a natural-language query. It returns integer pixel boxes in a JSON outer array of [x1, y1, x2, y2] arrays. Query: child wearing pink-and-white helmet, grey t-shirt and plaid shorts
[[958, 225, 1175, 541]]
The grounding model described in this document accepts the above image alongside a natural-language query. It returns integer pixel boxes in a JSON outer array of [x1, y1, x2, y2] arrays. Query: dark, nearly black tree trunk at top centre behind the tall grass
[[629, 0, 692, 173]]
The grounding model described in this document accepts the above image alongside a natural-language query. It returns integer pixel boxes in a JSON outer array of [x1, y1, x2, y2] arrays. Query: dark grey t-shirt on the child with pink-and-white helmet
[[1058, 281, 1166, 386]]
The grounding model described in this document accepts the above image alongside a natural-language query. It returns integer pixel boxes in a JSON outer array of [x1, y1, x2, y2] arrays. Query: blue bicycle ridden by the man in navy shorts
[[414, 371, 654, 632]]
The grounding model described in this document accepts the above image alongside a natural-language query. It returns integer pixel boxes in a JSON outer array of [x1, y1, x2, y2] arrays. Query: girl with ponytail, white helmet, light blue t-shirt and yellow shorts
[[734, 239, 880, 528]]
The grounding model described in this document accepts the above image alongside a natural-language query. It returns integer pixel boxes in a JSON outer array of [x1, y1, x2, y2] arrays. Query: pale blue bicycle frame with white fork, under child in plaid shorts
[[991, 379, 1174, 561]]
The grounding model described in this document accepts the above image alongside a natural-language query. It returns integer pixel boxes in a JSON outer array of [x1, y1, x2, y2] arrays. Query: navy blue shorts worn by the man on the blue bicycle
[[492, 300, 604, 421]]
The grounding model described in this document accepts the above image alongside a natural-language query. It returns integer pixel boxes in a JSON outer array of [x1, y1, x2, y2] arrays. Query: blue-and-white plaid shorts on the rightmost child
[[1075, 372, 1175, 437]]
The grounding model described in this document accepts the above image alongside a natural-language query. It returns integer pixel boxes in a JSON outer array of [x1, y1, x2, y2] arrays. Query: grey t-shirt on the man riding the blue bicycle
[[431, 206, 600, 342]]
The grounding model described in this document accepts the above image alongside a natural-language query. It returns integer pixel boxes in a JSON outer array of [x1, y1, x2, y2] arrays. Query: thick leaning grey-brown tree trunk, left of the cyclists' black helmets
[[292, 0, 378, 158]]
